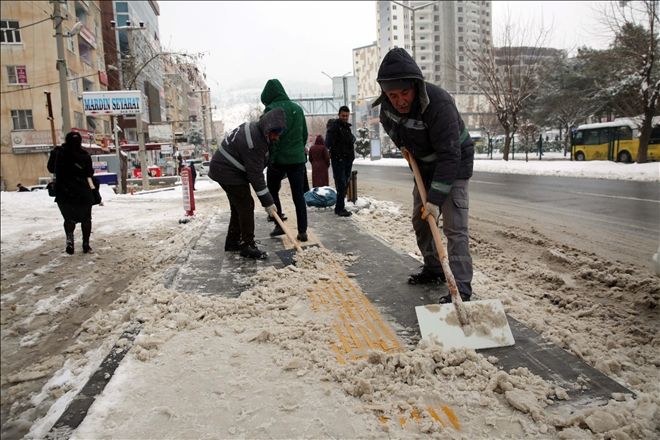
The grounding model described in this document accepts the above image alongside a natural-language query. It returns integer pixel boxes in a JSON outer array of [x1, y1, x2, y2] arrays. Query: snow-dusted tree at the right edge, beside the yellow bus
[[605, 0, 660, 163]]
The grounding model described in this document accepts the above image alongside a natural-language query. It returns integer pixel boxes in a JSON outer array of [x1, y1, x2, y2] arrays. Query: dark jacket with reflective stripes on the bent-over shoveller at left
[[209, 109, 286, 206]]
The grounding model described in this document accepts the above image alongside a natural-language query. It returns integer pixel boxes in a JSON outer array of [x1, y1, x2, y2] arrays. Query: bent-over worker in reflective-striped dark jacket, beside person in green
[[209, 109, 286, 259]]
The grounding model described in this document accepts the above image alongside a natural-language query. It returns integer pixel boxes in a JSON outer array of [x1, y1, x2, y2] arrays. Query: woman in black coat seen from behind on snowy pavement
[[48, 132, 94, 254]]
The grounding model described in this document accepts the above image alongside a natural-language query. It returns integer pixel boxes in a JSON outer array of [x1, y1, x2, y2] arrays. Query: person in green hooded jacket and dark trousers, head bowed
[[261, 79, 307, 241]]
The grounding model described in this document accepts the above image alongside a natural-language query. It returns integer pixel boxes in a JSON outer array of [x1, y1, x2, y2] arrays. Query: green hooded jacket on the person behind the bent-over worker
[[261, 79, 307, 165]]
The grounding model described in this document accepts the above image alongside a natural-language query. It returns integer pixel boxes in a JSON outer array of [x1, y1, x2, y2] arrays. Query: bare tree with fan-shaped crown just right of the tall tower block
[[462, 18, 548, 160]]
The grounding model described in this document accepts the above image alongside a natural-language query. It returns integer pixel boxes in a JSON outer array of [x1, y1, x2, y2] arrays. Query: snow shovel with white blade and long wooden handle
[[403, 148, 515, 350]]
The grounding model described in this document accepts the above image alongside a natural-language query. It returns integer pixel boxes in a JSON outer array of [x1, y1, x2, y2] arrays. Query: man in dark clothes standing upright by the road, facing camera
[[325, 105, 355, 217]]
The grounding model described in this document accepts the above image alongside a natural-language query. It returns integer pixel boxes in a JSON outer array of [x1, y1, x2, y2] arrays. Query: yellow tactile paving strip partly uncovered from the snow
[[282, 230, 461, 431]]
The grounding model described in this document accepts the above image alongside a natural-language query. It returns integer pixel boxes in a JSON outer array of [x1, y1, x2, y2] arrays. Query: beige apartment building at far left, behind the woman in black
[[0, 0, 111, 190]]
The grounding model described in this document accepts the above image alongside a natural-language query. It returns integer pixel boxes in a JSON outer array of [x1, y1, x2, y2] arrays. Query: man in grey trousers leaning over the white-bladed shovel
[[372, 48, 474, 303]]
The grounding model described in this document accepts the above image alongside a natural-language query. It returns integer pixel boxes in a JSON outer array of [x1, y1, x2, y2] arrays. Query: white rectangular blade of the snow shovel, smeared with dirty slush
[[415, 299, 516, 350]]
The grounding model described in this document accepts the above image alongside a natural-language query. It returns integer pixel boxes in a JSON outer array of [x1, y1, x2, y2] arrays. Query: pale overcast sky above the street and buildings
[[159, 1, 607, 99]]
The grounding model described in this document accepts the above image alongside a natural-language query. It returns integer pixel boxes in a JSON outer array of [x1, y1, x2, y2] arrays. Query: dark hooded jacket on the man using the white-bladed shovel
[[372, 48, 474, 206]]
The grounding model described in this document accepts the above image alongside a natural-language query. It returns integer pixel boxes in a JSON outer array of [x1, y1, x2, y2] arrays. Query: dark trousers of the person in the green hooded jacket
[[266, 163, 307, 233]]
